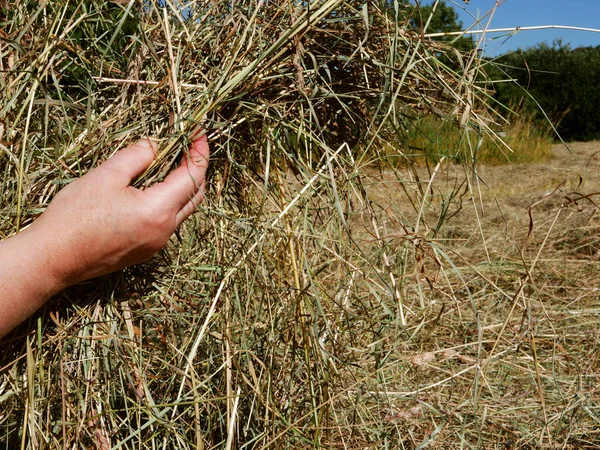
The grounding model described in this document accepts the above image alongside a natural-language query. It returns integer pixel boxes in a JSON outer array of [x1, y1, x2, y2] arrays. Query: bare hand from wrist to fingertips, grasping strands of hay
[[21, 137, 209, 290]]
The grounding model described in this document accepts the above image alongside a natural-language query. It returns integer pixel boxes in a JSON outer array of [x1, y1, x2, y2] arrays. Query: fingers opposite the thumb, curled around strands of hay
[[146, 136, 210, 214]]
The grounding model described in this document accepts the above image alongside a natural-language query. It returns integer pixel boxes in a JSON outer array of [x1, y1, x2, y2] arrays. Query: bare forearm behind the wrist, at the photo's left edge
[[0, 230, 66, 337]]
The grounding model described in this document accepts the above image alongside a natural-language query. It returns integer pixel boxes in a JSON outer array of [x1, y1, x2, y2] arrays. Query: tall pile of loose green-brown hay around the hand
[[0, 0, 504, 449]]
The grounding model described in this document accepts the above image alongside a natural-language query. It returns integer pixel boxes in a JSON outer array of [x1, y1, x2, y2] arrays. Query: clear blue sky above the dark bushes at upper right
[[448, 0, 600, 55]]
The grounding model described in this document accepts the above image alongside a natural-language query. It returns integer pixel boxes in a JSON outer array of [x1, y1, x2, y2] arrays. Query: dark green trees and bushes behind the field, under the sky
[[412, 0, 600, 141]]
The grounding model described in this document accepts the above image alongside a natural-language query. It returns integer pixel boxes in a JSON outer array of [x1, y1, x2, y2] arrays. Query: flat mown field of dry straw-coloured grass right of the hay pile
[[350, 142, 600, 448]]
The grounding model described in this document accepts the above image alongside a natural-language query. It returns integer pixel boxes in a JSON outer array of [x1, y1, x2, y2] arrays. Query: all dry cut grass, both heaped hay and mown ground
[[0, 1, 600, 450]]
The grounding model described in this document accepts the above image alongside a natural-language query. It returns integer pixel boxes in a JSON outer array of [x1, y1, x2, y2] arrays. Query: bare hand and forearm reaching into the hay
[[0, 137, 209, 337]]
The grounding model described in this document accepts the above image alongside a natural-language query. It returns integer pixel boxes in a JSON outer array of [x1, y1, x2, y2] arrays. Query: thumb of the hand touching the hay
[[100, 139, 156, 186]]
